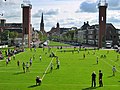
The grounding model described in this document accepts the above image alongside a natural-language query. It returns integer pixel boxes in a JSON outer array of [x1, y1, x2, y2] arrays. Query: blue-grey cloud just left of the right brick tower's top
[[76, 1, 97, 13]]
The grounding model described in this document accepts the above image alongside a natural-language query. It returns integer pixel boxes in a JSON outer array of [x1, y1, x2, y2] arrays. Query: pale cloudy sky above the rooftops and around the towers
[[0, 0, 120, 31]]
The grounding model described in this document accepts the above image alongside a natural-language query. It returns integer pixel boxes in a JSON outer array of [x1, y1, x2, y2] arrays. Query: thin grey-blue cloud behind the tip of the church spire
[[33, 9, 59, 17]]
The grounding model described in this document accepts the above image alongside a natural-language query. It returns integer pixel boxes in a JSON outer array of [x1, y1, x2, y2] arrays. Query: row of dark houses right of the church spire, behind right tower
[[48, 21, 120, 46]]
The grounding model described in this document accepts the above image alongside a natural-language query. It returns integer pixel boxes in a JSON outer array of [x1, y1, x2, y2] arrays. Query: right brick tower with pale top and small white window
[[98, 0, 108, 48]]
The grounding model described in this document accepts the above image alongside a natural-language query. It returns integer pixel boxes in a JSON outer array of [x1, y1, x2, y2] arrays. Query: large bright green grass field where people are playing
[[0, 48, 120, 90]]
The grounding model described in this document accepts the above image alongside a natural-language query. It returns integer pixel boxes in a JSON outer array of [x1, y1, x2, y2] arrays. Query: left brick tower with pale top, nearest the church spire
[[21, 0, 32, 47]]
